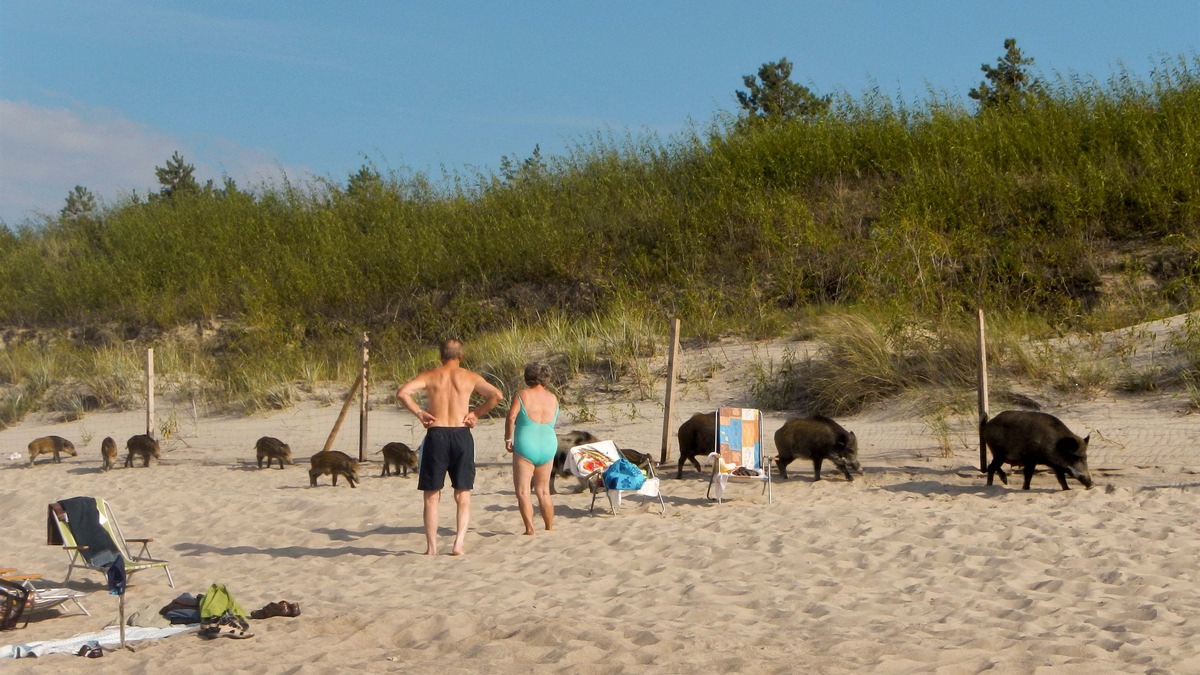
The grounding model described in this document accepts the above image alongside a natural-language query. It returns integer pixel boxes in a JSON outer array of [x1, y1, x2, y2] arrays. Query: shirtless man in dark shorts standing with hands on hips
[[396, 340, 504, 555]]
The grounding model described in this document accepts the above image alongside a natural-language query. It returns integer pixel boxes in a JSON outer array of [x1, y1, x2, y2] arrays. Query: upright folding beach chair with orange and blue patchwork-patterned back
[[708, 408, 772, 504]]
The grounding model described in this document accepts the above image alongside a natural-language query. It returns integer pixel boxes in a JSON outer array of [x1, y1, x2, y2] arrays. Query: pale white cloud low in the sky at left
[[0, 100, 306, 227]]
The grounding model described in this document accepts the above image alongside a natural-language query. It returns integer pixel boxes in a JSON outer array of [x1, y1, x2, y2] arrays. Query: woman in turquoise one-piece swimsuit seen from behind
[[504, 363, 558, 534]]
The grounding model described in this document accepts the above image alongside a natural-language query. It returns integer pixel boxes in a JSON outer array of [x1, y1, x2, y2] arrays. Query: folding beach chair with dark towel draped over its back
[[46, 497, 175, 589]]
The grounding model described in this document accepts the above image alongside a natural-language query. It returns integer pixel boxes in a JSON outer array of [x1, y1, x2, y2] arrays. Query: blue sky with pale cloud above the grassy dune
[[0, 0, 1200, 227]]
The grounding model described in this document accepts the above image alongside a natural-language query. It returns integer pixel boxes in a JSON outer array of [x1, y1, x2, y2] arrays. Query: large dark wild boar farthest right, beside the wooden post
[[979, 411, 1092, 490]]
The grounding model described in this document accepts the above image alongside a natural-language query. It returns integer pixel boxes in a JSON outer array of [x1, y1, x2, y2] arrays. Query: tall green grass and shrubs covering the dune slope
[[0, 58, 1200, 417]]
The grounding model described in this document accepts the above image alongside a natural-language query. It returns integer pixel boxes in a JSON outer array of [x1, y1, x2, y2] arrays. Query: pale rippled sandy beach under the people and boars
[[0, 338, 1200, 674]]
